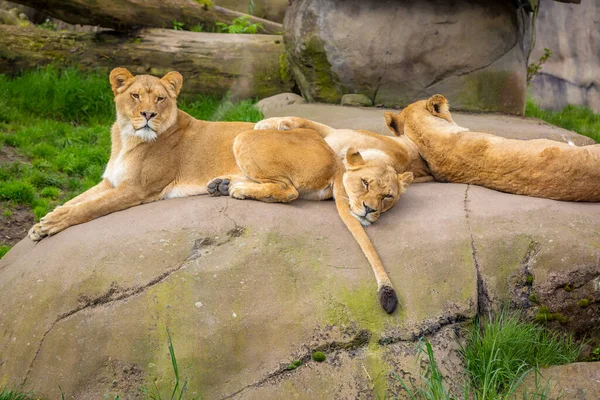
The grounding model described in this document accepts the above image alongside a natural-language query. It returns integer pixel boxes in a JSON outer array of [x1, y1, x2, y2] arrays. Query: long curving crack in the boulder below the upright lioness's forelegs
[[21, 233, 237, 386]]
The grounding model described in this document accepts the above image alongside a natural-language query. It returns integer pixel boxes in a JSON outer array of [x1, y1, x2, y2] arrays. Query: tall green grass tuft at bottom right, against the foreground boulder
[[396, 311, 581, 400]]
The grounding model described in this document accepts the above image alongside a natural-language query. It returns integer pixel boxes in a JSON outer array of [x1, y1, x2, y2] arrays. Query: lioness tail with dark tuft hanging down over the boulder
[[333, 172, 398, 314]]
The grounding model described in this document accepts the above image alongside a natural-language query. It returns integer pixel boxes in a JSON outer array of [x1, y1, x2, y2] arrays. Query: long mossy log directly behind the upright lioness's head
[[0, 25, 291, 98]]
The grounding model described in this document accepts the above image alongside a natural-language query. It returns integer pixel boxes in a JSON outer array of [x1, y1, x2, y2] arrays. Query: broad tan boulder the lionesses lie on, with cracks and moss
[[0, 105, 600, 399]]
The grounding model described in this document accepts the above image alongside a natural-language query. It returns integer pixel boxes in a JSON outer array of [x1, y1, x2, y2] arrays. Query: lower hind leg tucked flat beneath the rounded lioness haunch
[[229, 179, 299, 203]]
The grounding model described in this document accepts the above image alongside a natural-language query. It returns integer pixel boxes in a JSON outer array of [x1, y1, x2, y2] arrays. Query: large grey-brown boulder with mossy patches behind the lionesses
[[284, 0, 532, 114]]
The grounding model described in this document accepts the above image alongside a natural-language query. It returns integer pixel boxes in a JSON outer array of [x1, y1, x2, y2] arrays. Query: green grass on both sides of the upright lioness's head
[[0, 68, 262, 257]]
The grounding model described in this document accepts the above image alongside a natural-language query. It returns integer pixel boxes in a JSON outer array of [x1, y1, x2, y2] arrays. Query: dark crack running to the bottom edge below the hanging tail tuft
[[221, 329, 371, 400]]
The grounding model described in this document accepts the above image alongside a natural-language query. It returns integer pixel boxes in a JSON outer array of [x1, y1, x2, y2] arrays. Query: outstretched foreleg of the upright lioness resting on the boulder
[[29, 184, 150, 241]]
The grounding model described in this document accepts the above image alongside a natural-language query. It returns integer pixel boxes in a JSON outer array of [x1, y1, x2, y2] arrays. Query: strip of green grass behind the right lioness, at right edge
[[525, 97, 600, 143]]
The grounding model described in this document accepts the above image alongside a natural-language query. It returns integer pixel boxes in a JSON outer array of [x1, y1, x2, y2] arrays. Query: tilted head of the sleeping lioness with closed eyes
[[344, 148, 413, 226]]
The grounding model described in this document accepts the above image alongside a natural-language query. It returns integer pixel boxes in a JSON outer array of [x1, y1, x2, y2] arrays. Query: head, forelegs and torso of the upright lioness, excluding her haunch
[[29, 68, 254, 240]]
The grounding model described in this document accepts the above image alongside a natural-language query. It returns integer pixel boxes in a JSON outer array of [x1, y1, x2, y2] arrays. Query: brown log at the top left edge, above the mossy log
[[11, 0, 283, 34]]
